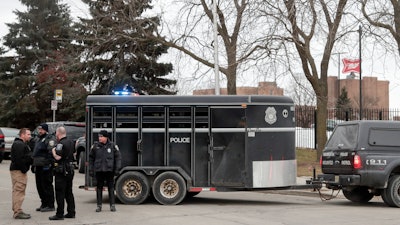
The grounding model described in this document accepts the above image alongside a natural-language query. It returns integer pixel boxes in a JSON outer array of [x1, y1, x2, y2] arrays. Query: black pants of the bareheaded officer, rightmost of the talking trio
[[55, 171, 75, 217]]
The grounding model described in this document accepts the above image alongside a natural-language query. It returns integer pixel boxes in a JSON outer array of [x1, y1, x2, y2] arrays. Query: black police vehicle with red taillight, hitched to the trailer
[[318, 120, 400, 207]]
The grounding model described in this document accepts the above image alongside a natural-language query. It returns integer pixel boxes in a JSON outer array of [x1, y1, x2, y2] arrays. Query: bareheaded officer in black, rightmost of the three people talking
[[49, 127, 75, 220]]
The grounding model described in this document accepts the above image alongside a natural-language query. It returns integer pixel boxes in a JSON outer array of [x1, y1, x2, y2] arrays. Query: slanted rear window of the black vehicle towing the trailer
[[326, 124, 359, 149]]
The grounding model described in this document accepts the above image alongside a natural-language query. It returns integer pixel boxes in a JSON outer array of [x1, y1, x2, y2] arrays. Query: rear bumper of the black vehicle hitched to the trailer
[[317, 174, 361, 186]]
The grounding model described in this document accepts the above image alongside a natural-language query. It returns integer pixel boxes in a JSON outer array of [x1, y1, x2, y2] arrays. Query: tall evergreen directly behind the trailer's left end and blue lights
[[77, 0, 176, 95]]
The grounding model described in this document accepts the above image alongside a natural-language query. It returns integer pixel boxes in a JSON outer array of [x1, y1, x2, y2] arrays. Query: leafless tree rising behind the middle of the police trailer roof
[[152, 0, 268, 95]]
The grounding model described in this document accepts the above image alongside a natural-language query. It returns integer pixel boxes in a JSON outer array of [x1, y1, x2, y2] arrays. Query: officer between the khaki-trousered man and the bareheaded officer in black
[[32, 123, 56, 212]]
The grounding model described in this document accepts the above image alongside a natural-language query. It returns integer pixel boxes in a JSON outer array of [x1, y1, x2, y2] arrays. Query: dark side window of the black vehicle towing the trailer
[[368, 128, 400, 147]]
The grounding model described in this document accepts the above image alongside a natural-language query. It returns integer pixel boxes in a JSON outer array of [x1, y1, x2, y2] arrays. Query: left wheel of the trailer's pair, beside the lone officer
[[115, 172, 150, 205]]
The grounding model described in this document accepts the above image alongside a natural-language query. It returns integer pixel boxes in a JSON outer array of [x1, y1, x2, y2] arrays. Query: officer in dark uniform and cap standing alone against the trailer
[[89, 130, 121, 212]]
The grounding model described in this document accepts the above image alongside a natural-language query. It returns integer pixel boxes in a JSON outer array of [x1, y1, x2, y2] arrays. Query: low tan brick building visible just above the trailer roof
[[193, 82, 283, 95]]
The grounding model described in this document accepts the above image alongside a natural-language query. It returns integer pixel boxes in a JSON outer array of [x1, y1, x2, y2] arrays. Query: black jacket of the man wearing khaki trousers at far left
[[10, 138, 32, 173]]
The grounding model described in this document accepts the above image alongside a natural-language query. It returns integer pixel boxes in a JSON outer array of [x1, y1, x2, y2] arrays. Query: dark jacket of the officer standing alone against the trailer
[[89, 141, 121, 173]]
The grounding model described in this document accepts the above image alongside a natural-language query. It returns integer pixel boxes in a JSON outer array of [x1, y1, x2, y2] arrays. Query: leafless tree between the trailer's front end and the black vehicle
[[259, 0, 347, 158]]
